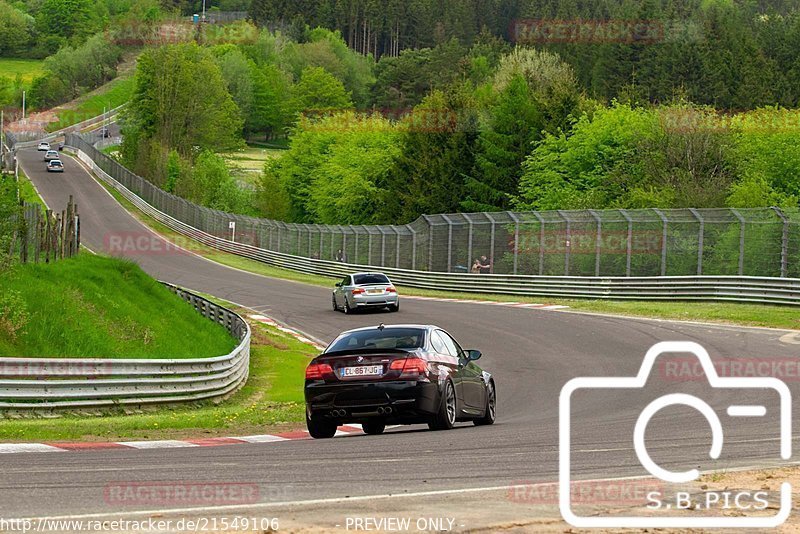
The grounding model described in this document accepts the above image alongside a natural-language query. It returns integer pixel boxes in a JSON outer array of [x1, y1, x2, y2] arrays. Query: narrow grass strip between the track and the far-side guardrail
[[89, 174, 800, 330]]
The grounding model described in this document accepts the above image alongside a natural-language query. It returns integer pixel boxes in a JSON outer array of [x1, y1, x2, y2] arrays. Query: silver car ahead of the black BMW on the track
[[331, 273, 400, 313]]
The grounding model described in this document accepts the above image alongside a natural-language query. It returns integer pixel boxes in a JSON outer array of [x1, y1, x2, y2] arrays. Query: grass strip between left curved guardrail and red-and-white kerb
[[0, 314, 315, 442]]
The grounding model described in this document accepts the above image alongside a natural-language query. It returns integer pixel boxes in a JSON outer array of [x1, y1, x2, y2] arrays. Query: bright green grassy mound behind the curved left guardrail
[[0, 253, 236, 358]]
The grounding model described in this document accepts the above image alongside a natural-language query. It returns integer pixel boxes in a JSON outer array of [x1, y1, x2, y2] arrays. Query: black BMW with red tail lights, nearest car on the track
[[305, 325, 497, 438]]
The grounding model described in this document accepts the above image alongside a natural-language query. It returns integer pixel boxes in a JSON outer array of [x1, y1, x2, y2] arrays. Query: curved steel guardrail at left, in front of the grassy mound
[[0, 284, 250, 410]]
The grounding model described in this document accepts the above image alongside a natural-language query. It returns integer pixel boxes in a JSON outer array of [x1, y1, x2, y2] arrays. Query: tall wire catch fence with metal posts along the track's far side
[[66, 133, 800, 278]]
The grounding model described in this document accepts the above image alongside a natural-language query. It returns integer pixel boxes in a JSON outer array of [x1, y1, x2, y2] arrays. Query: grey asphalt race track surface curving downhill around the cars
[[0, 150, 798, 517]]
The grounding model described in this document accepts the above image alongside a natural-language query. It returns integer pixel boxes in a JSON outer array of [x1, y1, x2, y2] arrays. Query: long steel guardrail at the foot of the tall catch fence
[[70, 146, 800, 305]]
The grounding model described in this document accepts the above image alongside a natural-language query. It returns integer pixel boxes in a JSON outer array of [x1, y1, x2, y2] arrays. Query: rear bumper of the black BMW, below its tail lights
[[305, 381, 441, 423]]
